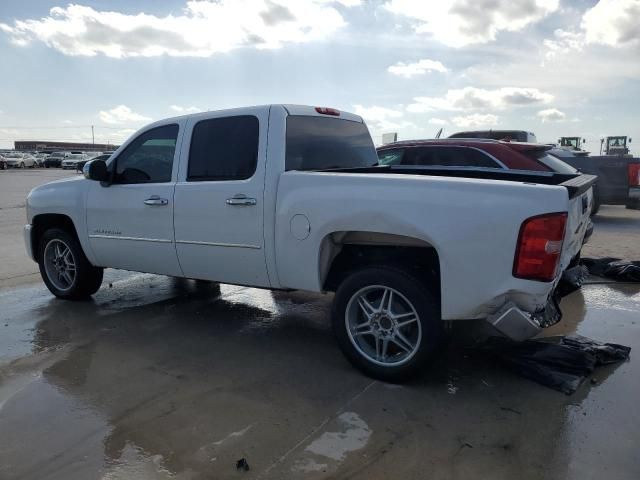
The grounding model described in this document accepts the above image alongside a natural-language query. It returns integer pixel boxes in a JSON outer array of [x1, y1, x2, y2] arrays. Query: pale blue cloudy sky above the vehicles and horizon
[[0, 0, 640, 154]]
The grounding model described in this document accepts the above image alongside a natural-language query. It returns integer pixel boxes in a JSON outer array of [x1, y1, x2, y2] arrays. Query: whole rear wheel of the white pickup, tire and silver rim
[[332, 266, 442, 382]]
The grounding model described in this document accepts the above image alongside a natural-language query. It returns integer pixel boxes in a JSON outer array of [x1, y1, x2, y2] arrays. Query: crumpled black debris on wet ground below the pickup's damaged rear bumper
[[475, 335, 631, 395]]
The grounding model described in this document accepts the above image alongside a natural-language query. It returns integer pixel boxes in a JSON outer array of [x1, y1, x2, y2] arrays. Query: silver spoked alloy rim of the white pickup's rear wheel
[[345, 285, 422, 367]]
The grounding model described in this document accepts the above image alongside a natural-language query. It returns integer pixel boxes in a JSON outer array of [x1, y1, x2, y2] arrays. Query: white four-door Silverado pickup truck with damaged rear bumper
[[24, 105, 595, 380]]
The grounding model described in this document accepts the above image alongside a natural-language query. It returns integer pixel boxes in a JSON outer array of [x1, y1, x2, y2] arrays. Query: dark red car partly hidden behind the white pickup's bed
[[378, 138, 578, 174]]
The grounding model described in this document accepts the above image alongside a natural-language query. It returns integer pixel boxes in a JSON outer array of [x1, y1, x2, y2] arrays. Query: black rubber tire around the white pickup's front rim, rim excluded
[[38, 228, 103, 300]]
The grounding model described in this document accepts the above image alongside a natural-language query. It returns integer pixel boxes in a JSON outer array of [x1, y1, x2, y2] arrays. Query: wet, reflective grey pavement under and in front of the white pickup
[[0, 272, 640, 480]]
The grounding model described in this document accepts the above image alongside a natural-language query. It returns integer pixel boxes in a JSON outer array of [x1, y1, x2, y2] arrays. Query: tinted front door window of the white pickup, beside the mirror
[[113, 125, 179, 184]]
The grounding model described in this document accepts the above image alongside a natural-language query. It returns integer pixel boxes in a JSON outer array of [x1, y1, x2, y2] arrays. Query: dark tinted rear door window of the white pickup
[[187, 115, 259, 182]]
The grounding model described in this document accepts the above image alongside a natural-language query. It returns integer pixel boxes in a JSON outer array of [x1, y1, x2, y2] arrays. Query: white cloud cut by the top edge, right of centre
[[385, 0, 559, 47]]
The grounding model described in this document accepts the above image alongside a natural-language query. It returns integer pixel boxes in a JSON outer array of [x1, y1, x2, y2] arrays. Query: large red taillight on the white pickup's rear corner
[[513, 213, 567, 282]]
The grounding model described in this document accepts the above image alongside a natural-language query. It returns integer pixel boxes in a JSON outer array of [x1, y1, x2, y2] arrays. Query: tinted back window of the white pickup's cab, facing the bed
[[286, 115, 378, 170]]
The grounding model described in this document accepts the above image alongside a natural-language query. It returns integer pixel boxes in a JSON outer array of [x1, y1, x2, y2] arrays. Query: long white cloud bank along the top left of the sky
[[0, 0, 355, 58]]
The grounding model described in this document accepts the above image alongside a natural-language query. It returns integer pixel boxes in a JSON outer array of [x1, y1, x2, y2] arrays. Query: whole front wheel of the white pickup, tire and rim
[[38, 228, 103, 300]]
